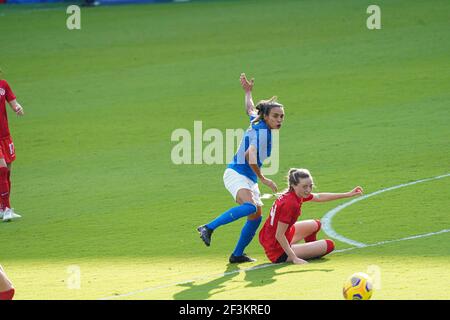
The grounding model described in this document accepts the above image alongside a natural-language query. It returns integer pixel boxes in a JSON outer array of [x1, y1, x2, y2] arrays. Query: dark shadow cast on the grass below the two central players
[[173, 259, 334, 300]]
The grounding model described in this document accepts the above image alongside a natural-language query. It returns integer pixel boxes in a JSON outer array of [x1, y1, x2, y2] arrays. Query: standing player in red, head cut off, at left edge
[[0, 70, 24, 222]]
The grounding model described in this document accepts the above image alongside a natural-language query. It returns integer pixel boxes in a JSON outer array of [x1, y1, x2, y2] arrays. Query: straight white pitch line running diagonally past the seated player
[[99, 229, 450, 300]]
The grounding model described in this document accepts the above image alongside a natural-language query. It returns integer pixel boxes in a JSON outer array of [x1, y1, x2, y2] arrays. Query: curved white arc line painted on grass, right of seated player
[[321, 173, 450, 248]]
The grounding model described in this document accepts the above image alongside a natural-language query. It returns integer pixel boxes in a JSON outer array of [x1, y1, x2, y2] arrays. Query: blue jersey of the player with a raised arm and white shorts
[[228, 116, 272, 183]]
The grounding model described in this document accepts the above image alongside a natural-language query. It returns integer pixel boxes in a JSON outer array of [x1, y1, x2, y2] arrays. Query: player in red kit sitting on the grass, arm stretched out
[[259, 169, 363, 264]]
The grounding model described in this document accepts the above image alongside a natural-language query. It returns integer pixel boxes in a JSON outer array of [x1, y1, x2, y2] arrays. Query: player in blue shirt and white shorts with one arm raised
[[197, 74, 284, 263]]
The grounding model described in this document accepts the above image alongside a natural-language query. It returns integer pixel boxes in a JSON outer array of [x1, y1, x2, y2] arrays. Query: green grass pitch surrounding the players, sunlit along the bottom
[[0, 0, 450, 299]]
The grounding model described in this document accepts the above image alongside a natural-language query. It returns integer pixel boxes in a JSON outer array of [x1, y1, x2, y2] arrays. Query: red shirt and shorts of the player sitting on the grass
[[259, 191, 313, 262]]
